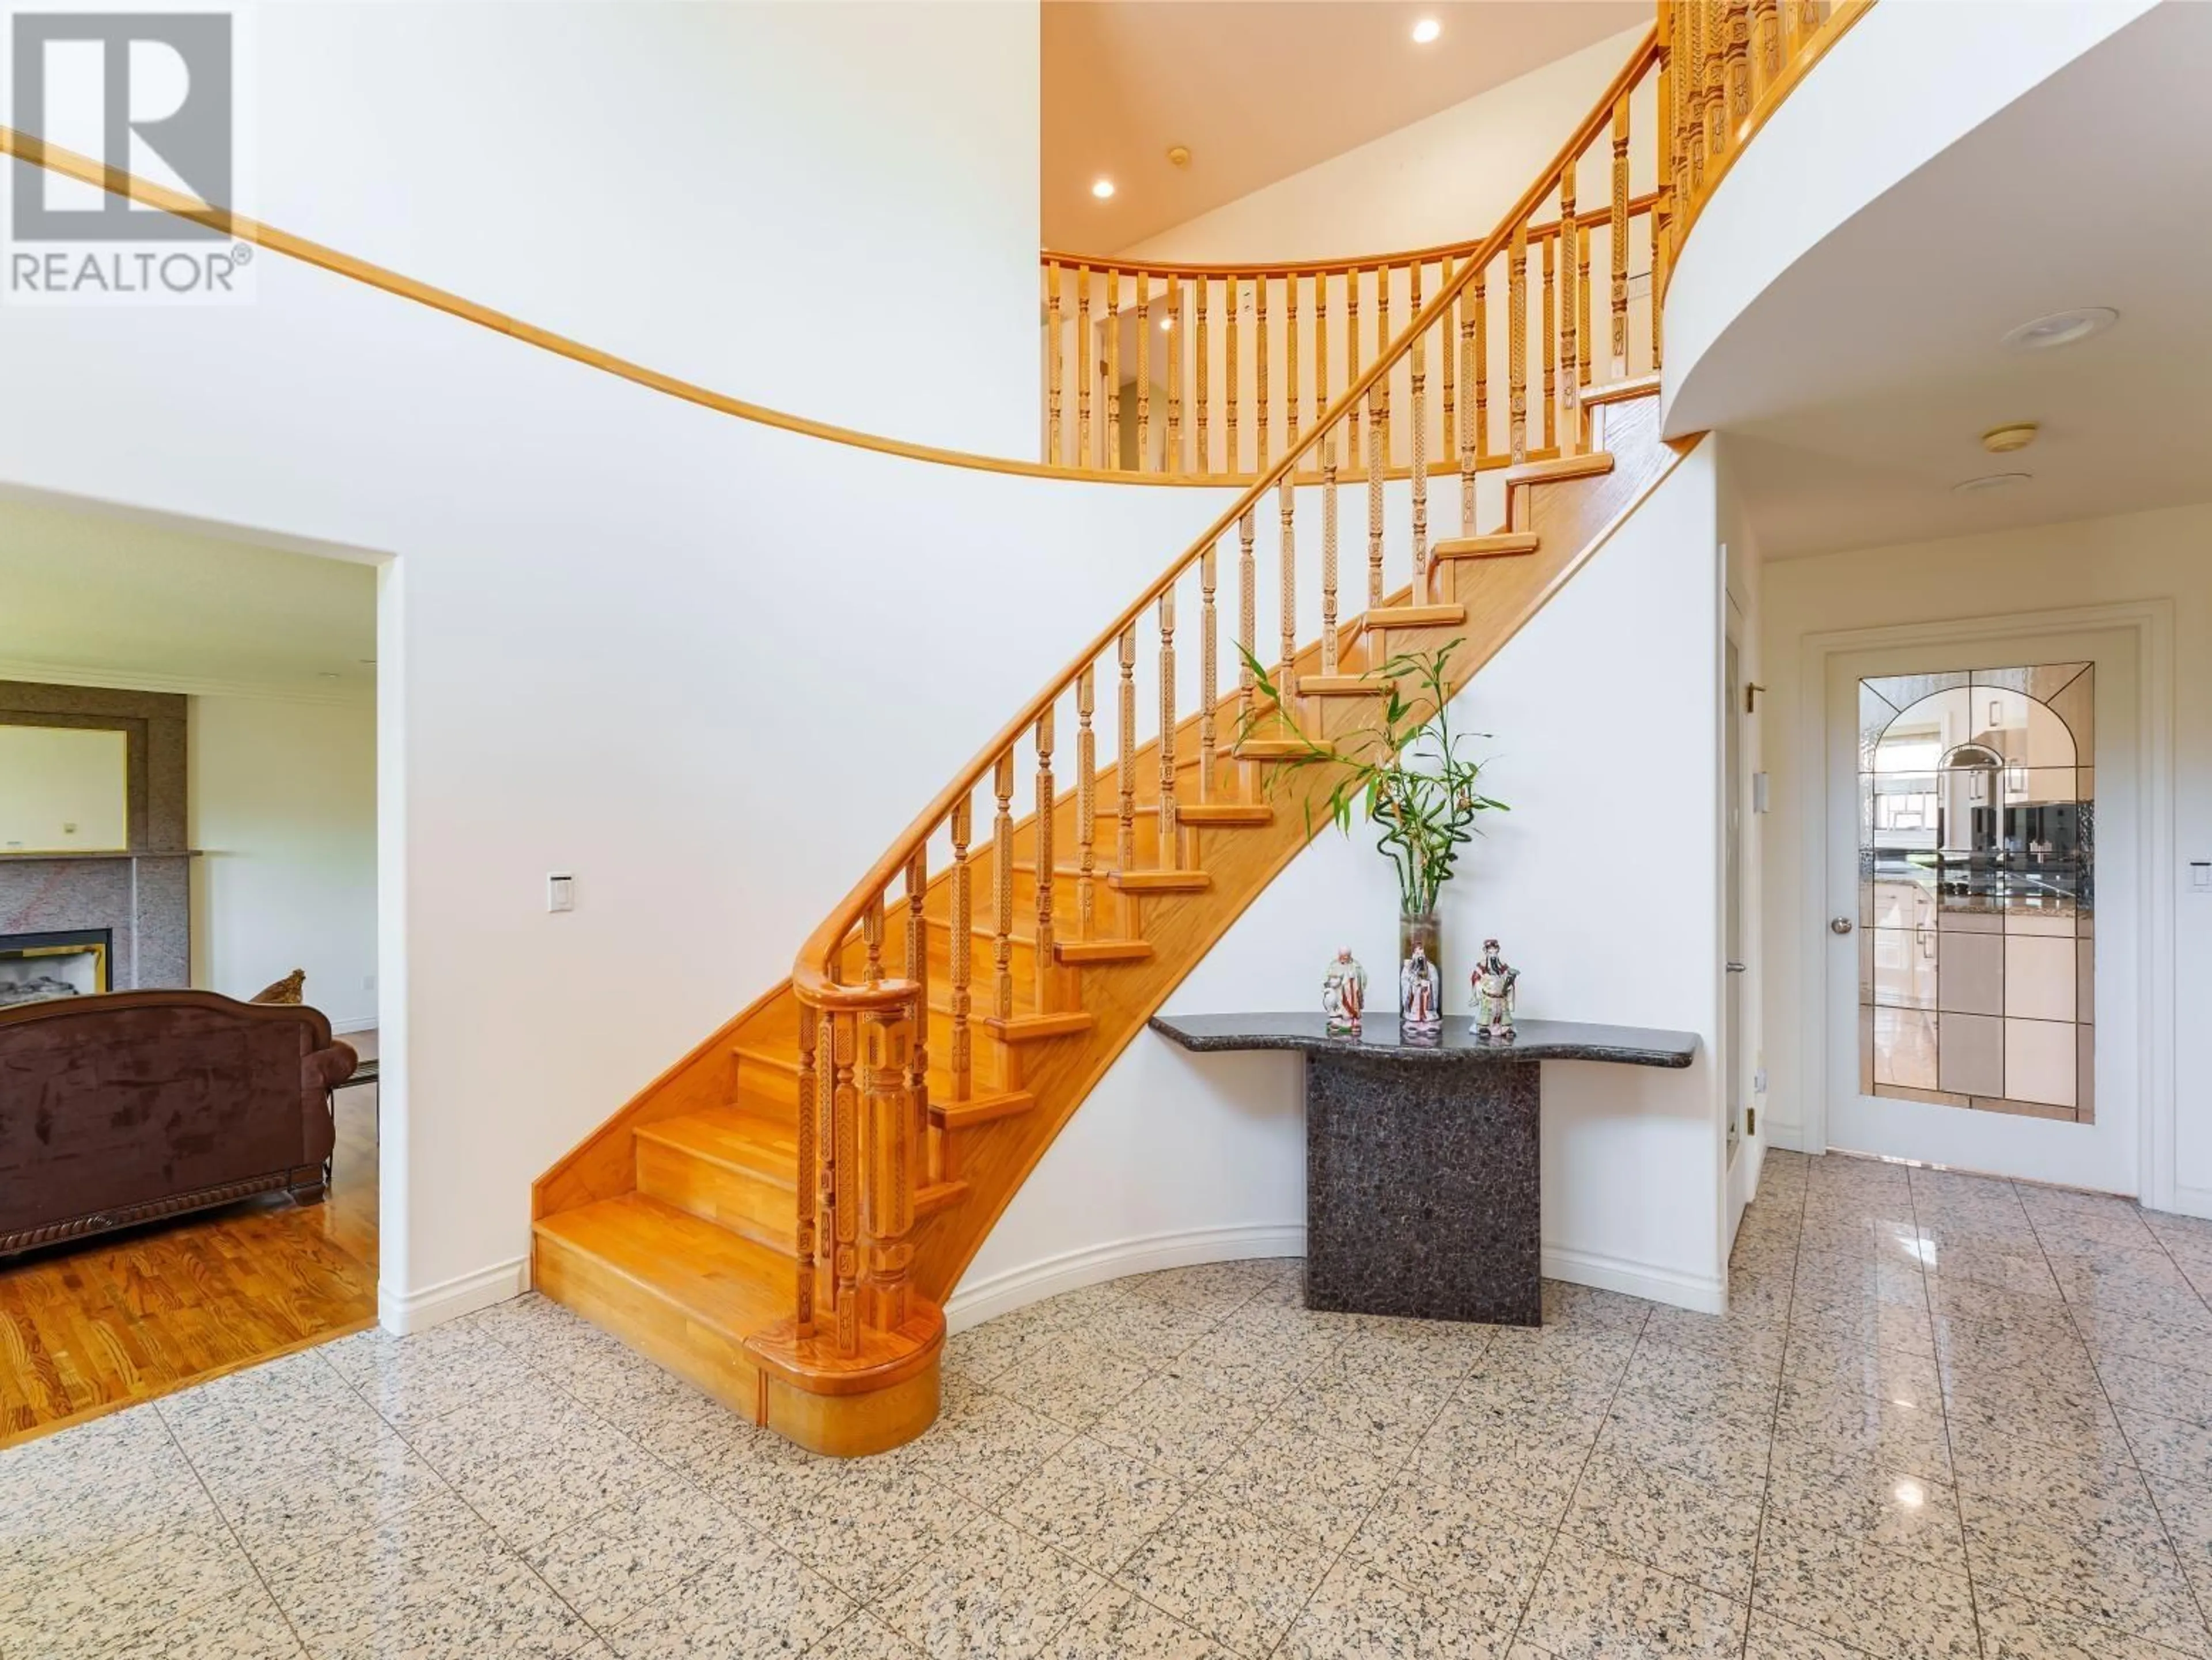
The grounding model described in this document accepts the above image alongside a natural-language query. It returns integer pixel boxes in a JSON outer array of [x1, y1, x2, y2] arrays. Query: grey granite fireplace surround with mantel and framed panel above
[[0, 679, 192, 992]]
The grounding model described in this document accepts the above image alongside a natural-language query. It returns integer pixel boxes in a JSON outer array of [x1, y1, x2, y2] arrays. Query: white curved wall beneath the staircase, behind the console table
[[953, 443, 1725, 1321]]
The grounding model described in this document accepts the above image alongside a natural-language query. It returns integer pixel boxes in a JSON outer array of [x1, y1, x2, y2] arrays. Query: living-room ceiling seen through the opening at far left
[[0, 496, 376, 699]]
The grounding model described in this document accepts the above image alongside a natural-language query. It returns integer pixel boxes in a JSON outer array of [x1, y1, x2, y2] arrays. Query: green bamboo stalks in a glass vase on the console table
[[1238, 640, 1506, 1042]]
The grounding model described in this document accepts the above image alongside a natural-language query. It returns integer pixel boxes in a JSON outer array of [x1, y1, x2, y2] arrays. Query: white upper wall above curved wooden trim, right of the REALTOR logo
[[80, 0, 1040, 456]]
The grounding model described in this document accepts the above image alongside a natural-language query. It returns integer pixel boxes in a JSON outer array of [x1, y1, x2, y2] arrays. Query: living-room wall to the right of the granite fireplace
[[186, 697, 376, 1031]]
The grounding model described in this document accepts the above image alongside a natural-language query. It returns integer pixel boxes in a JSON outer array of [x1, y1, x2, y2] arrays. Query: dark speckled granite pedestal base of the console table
[[1305, 1052, 1544, 1326]]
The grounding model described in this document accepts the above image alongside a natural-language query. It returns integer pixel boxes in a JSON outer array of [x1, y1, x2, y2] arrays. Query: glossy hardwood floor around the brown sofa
[[0, 1034, 376, 1447]]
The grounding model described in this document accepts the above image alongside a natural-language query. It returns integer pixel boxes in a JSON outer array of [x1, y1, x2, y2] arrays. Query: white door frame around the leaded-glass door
[[1791, 600, 2185, 1215]]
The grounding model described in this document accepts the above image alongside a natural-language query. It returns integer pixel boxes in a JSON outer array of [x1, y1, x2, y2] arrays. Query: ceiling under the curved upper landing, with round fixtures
[[1675, 5, 2212, 558]]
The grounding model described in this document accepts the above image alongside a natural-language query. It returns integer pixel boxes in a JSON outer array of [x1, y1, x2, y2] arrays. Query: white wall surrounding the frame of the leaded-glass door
[[1765, 507, 2212, 1215]]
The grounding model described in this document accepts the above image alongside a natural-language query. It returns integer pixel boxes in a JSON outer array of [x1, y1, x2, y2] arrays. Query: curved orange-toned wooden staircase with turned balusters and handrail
[[533, 40, 1677, 1454]]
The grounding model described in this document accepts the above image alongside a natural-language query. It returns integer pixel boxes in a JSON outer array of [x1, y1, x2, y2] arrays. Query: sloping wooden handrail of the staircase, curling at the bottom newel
[[792, 29, 1659, 1009]]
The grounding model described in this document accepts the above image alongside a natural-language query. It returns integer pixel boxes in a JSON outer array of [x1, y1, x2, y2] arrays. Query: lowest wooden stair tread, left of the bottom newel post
[[533, 1193, 798, 1341]]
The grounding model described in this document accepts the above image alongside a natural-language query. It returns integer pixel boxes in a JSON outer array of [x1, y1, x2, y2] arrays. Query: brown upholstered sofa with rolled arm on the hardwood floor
[[0, 992, 354, 1253]]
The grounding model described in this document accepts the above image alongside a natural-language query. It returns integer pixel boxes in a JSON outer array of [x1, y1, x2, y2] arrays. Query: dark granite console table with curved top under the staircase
[[1153, 1014, 1696, 1326]]
